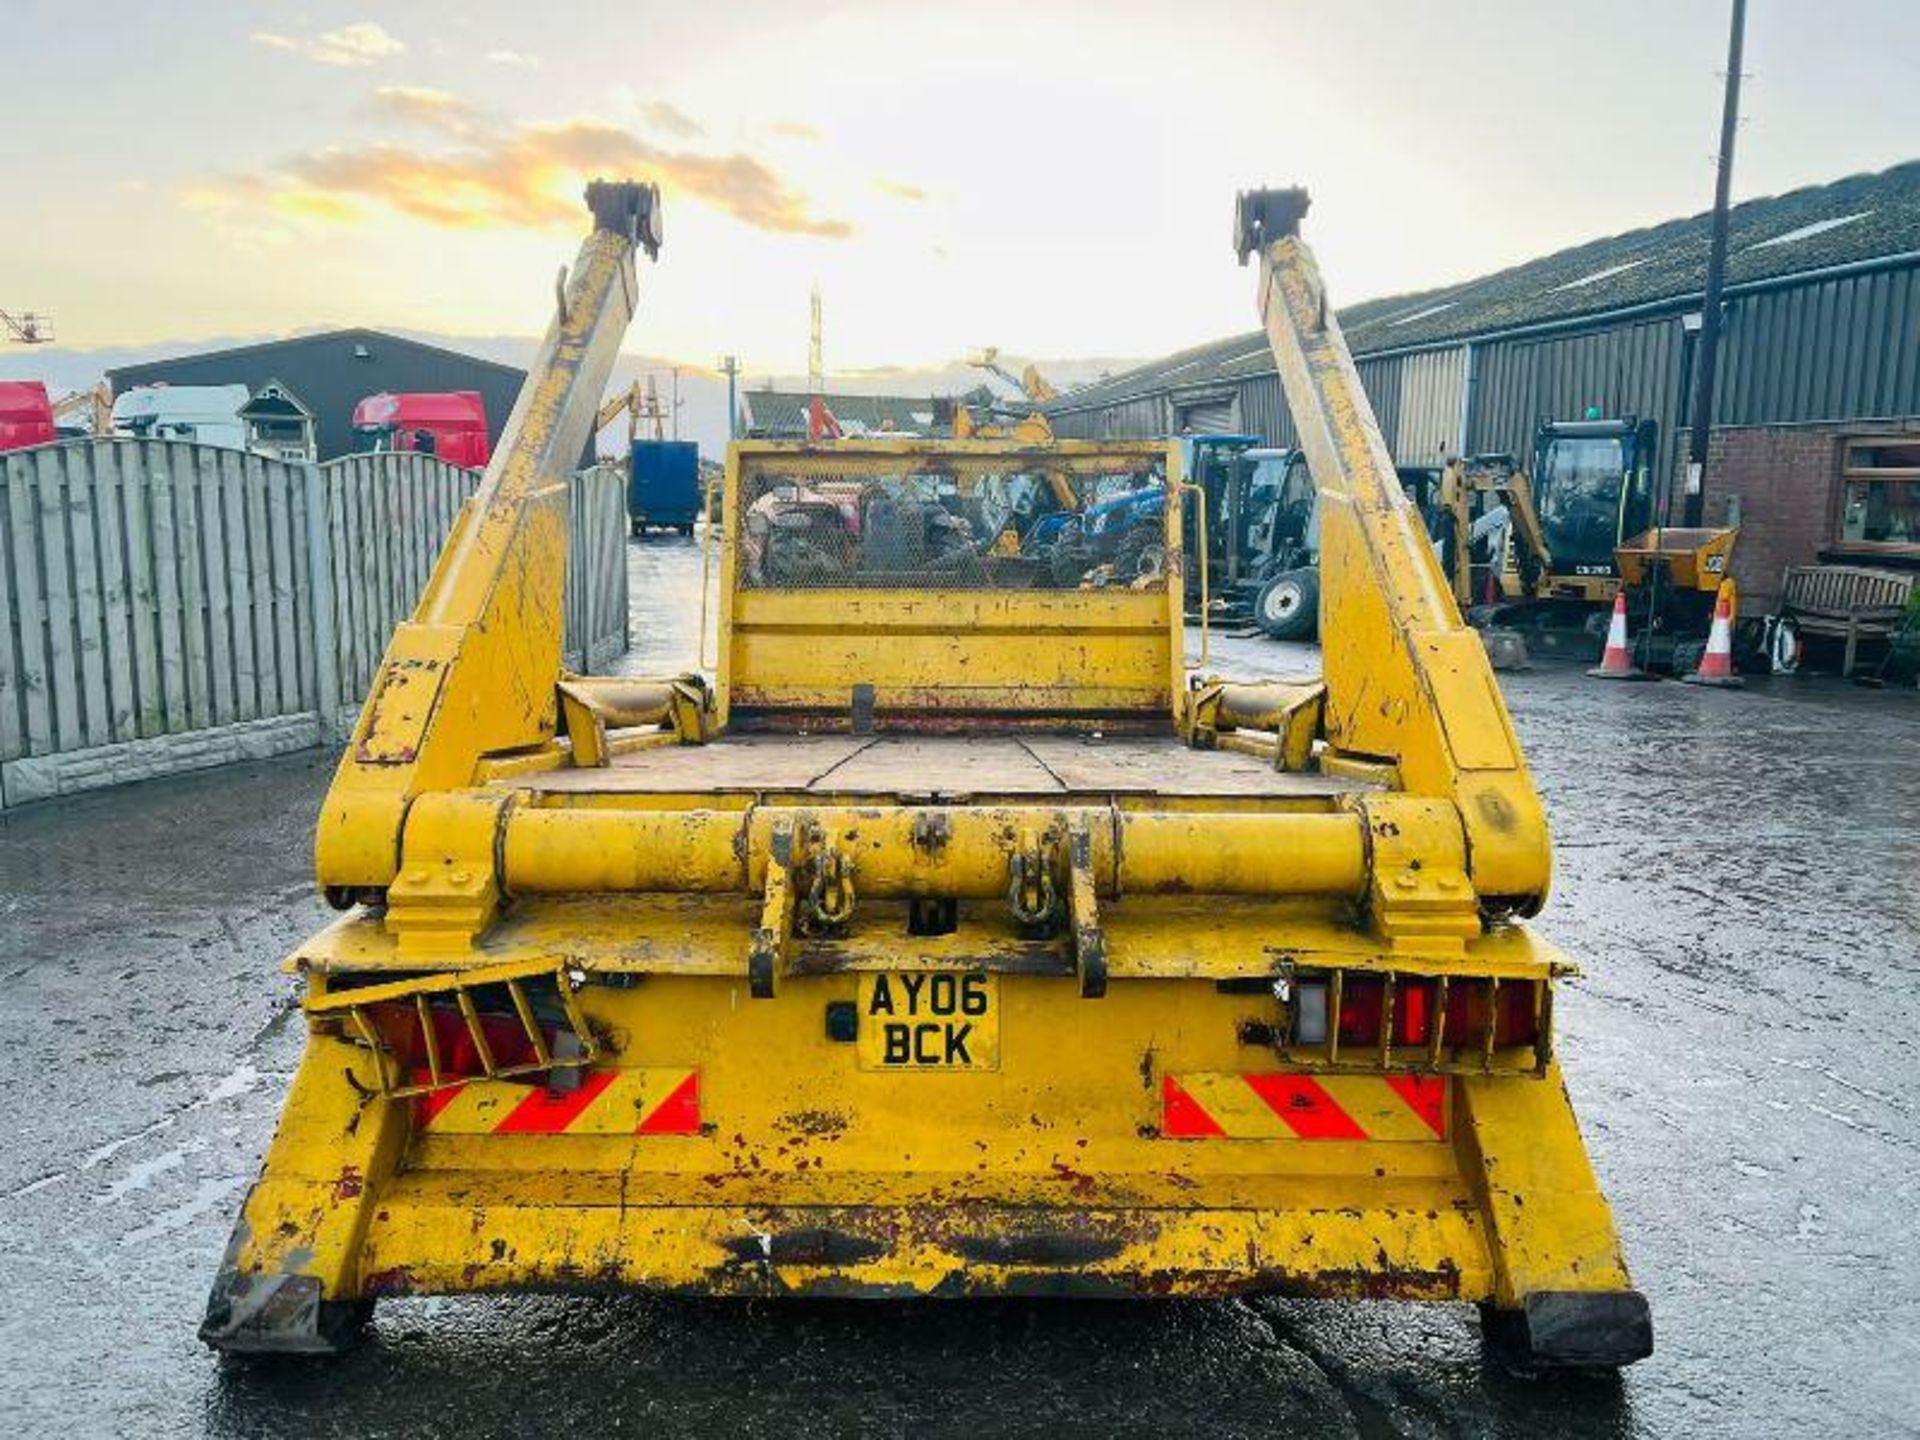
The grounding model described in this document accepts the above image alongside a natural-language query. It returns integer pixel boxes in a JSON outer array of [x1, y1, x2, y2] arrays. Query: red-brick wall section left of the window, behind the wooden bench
[[1703, 424, 1859, 614]]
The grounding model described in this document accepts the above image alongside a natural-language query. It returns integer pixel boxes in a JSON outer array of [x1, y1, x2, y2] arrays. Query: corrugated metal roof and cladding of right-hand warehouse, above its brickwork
[[1048, 161, 1920, 465]]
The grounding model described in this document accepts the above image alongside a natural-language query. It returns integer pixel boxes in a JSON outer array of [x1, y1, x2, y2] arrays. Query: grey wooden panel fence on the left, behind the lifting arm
[[0, 440, 626, 806]]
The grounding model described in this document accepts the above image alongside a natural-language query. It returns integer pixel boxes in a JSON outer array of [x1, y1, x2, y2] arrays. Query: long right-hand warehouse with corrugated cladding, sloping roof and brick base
[[1046, 161, 1920, 605]]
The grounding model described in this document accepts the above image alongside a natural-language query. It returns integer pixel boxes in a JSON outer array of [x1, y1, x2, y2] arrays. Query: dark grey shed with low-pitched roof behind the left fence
[[108, 330, 526, 461]]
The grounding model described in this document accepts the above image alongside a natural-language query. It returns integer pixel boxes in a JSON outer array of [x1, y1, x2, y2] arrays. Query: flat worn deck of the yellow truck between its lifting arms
[[505, 735, 1371, 801]]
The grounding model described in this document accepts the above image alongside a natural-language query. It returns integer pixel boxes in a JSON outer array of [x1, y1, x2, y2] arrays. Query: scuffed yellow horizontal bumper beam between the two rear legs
[[363, 1183, 1492, 1300]]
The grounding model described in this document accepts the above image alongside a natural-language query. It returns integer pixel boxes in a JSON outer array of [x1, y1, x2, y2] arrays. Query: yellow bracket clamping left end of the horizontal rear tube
[[386, 791, 513, 956]]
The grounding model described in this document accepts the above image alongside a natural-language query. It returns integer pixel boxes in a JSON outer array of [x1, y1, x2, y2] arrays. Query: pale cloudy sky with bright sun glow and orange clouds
[[11, 0, 1920, 372]]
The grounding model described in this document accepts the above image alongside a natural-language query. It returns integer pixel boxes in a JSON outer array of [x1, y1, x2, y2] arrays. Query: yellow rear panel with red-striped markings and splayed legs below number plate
[[202, 975, 1644, 1363]]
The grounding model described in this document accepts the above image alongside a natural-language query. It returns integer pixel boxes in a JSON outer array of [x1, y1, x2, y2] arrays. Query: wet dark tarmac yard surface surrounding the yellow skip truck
[[0, 540, 1920, 1440]]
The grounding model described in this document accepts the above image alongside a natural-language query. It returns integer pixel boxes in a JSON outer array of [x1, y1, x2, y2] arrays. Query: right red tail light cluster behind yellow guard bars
[[1292, 972, 1540, 1050]]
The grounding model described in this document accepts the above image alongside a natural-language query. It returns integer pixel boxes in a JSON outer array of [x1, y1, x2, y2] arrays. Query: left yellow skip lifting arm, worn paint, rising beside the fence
[[315, 180, 660, 897]]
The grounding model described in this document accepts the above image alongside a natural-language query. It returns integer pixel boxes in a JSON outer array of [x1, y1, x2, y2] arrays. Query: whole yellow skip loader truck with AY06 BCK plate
[[202, 182, 1651, 1367]]
